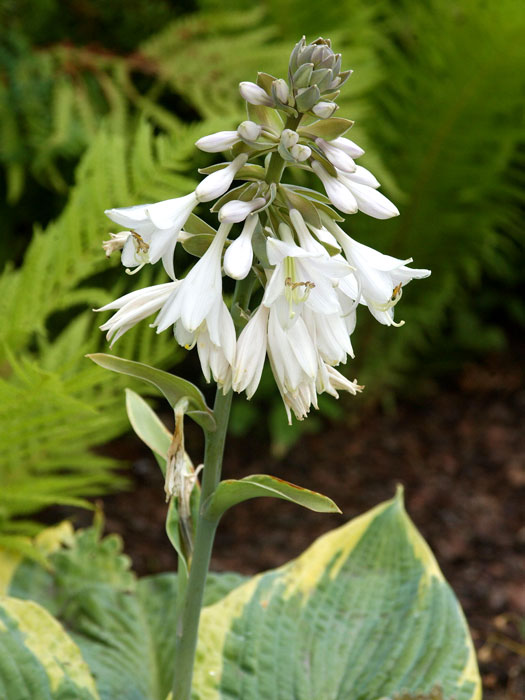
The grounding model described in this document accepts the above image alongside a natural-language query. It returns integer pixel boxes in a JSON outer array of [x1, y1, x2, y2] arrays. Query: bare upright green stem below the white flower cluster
[[172, 388, 232, 700]]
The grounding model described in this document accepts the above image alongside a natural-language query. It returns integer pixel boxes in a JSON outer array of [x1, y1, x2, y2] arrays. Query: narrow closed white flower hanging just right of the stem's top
[[232, 304, 269, 399]]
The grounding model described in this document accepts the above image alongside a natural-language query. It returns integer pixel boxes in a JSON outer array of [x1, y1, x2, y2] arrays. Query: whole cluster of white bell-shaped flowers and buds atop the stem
[[99, 38, 430, 421]]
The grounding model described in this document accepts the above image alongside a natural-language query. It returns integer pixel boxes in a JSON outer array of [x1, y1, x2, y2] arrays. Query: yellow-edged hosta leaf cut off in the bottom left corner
[[0, 596, 99, 700]]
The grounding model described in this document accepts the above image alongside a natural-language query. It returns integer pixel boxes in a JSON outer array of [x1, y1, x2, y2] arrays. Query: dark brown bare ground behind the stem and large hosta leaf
[[79, 355, 525, 700]]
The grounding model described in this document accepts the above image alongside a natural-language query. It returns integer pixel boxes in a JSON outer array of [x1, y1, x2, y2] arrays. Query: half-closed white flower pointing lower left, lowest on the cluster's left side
[[95, 281, 180, 347]]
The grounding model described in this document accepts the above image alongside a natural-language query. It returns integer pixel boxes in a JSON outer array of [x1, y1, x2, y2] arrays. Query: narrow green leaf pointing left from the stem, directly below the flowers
[[86, 352, 216, 431]]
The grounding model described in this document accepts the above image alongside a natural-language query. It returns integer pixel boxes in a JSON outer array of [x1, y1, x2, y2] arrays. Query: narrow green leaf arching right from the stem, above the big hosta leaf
[[203, 474, 341, 519]]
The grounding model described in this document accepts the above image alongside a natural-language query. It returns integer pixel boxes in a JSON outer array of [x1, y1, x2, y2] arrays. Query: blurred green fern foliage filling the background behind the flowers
[[0, 0, 525, 548]]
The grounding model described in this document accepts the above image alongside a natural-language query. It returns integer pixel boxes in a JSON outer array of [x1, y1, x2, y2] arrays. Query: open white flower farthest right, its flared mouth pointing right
[[325, 217, 430, 326]]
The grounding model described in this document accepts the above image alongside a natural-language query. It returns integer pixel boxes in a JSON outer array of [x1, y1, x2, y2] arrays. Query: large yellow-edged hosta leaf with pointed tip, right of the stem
[[194, 495, 481, 700]]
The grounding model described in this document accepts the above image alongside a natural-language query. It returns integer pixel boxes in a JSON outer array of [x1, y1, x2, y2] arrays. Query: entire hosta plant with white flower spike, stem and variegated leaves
[[0, 38, 480, 700]]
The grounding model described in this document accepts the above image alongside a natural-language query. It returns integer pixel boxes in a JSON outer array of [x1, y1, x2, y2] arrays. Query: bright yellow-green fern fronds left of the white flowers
[[0, 115, 233, 544]]
